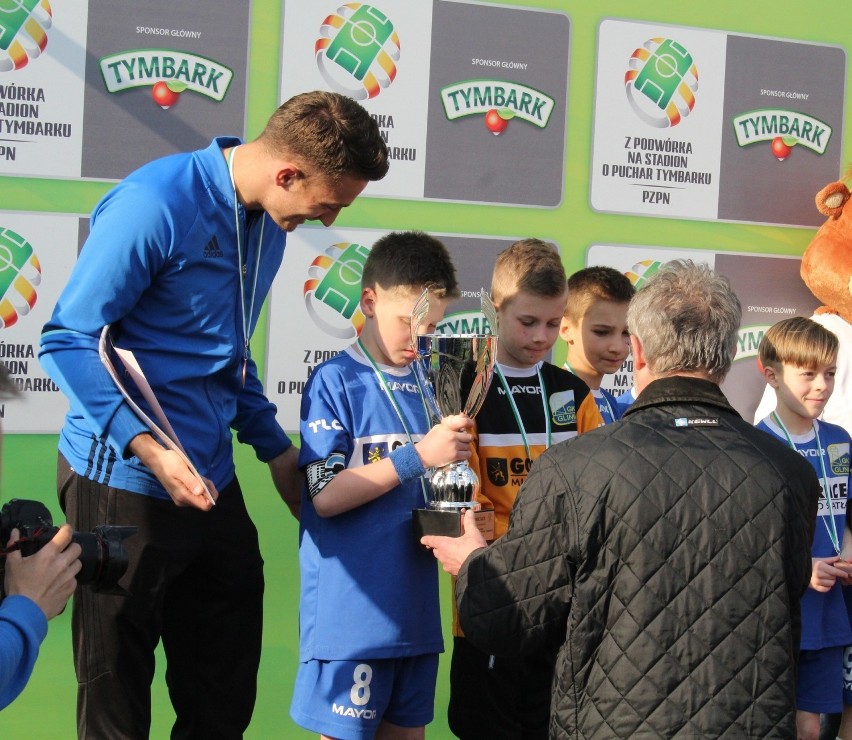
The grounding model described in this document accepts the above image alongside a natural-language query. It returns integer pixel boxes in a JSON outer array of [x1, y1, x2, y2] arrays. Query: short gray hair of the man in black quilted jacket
[[627, 260, 742, 383]]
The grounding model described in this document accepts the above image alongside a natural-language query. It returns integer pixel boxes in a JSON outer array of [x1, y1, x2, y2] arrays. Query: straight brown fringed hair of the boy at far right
[[757, 316, 840, 370]]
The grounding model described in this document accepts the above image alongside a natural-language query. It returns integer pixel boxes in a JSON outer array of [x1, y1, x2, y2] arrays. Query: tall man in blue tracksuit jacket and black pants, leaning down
[[39, 92, 388, 738]]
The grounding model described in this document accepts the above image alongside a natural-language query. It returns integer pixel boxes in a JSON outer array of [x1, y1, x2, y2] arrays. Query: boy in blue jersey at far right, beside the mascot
[[757, 316, 852, 738]]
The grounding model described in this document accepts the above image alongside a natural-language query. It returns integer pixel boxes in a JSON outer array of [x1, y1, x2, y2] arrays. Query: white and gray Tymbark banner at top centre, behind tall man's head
[[280, 0, 570, 207]]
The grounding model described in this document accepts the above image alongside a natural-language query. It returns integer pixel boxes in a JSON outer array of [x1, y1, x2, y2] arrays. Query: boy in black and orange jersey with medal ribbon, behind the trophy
[[448, 239, 603, 740]]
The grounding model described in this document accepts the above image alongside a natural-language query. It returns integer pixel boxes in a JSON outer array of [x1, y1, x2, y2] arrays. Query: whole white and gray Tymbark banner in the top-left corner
[[0, 0, 250, 180]]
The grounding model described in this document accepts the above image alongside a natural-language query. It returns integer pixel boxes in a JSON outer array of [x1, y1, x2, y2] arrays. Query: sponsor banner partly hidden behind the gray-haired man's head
[[586, 244, 819, 420]]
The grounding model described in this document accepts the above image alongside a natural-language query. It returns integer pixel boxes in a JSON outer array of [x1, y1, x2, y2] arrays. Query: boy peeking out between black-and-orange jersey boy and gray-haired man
[[559, 267, 636, 424]]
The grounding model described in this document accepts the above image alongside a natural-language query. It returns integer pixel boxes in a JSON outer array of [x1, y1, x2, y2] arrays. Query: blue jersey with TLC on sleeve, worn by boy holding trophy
[[299, 347, 444, 661]]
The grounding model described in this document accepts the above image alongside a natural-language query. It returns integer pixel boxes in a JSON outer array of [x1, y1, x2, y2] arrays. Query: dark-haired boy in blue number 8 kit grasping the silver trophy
[[290, 232, 472, 740]]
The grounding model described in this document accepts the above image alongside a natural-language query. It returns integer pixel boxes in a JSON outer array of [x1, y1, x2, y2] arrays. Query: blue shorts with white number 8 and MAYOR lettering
[[290, 654, 438, 740]]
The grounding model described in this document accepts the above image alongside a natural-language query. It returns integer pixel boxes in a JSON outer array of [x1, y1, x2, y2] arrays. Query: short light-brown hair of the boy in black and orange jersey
[[491, 239, 565, 306]]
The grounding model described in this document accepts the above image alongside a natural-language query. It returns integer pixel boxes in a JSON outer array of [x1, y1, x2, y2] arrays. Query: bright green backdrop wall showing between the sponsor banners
[[0, 0, 852, 739]]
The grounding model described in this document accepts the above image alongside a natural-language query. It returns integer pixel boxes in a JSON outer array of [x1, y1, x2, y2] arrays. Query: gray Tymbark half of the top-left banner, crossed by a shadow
[[81, 0, 250, 179]]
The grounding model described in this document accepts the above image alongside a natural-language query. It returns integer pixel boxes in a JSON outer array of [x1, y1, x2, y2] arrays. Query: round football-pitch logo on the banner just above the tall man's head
[[314, 3, 400, 100]]
